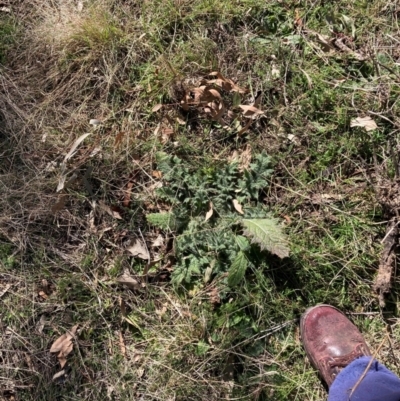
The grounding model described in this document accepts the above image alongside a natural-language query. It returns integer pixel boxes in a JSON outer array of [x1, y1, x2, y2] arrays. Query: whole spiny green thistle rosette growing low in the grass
[[147, 152, 289, 287]]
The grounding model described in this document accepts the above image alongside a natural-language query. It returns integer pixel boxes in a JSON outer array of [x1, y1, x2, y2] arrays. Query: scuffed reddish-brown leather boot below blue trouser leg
[[300, 305, 371, 387]]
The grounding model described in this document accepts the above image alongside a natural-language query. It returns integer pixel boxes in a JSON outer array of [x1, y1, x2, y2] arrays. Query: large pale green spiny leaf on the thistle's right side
[[242, 218, 289, 258]]
